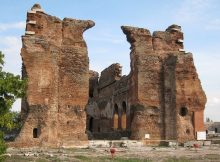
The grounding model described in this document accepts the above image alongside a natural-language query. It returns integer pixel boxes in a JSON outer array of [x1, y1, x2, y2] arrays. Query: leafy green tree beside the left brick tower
[[0, 51, 26, 157]]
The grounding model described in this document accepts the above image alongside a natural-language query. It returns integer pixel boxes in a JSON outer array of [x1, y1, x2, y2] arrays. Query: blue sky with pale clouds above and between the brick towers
[[0, 0, 220, 121]]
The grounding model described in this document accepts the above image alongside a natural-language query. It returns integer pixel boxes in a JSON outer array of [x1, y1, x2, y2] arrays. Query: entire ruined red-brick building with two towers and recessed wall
[[16, 5, 206, 147]]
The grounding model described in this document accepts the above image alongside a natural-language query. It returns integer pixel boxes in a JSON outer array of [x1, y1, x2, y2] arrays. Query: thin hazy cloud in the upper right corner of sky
[[174, 0, 220, 31]]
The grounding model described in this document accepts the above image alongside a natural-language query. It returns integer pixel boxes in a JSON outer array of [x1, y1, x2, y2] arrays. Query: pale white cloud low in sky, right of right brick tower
[[194, 46, 220, 121]]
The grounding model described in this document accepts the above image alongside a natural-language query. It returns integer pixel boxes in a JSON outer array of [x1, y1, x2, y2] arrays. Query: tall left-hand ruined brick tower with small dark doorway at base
[[16, 4, 94, 147]]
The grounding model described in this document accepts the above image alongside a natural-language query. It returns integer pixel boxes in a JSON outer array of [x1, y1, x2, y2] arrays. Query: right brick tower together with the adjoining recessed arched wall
[[87, 25, 206, 142]]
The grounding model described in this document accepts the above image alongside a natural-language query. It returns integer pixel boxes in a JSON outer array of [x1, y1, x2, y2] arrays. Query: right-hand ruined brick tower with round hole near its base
[[122, 25, 206, 141]]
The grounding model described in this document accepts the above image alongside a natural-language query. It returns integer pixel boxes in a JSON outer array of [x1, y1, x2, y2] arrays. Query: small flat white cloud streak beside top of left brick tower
[[0, 21, 26, 32]]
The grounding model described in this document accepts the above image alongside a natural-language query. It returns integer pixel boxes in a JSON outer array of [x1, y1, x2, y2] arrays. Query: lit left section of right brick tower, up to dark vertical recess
[[122, 26, 163, 139]]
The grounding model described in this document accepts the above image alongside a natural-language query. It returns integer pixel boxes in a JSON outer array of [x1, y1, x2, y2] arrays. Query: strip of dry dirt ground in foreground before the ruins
[[1, 145, 220, 162]]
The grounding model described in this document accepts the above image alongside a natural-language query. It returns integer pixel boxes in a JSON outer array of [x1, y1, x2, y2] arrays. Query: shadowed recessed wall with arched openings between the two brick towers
[[86, 63, 130, 139]]
